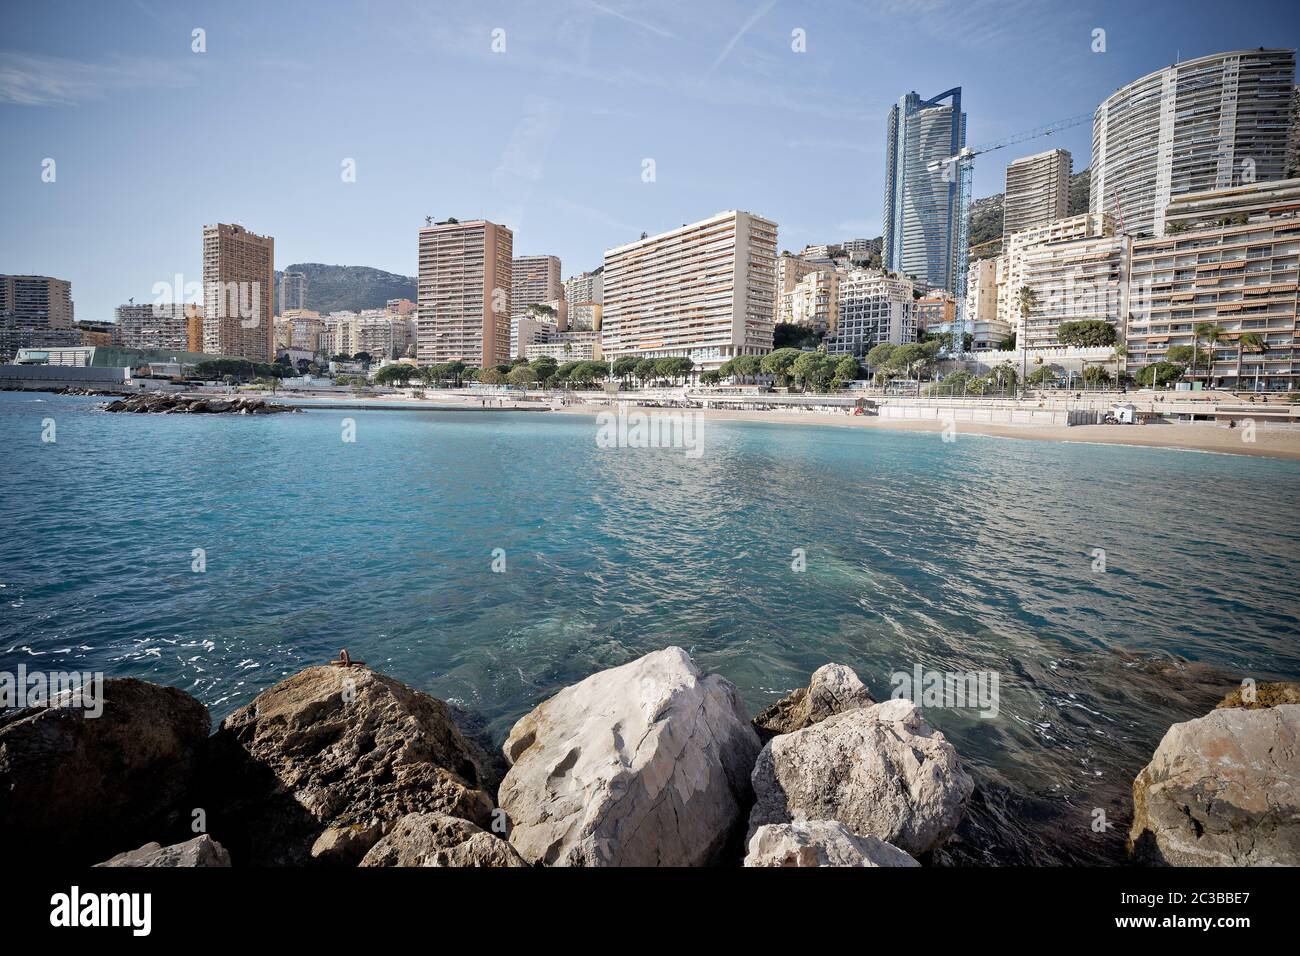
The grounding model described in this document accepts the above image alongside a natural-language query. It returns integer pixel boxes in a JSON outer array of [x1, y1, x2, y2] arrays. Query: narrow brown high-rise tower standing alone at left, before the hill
[[203, 222, 276, 363]]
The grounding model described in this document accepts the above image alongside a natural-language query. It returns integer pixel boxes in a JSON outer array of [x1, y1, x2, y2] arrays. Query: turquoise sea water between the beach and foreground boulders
[[0, 393, 1300, 861]]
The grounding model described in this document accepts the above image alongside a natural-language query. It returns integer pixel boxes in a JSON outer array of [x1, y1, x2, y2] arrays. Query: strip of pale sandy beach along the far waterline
[[546, 405, 1300, 460]]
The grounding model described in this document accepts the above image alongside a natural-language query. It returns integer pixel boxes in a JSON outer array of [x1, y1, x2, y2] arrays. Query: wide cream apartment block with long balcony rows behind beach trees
[[601, 209, 776, 369]]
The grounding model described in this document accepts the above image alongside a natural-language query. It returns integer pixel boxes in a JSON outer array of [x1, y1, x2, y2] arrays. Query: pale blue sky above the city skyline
[[0, 0, 1300, 320]]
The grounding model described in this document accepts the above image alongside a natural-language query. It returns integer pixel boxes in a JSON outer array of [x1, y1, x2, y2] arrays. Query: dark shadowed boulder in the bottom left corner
[[0, 678, 212, 864]]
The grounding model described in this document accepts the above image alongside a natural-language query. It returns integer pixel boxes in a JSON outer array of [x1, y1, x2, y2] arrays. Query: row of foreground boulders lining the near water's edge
[[0, 648, 1300, 868]]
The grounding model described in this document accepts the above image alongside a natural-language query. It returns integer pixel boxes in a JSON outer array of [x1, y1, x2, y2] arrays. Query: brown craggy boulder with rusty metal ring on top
[[207, 666, 493, 866]]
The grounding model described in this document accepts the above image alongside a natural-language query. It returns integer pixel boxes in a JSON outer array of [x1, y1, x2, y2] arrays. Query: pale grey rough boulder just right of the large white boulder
[[749, 700, 975, 856]]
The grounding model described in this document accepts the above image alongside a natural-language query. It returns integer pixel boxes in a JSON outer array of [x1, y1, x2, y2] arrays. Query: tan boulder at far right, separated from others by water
[[1128, 704, 1300, 866]]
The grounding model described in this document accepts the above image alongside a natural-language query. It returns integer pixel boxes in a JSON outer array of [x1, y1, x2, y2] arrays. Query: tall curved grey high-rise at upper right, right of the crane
[[1088, 48, 1296, 235]]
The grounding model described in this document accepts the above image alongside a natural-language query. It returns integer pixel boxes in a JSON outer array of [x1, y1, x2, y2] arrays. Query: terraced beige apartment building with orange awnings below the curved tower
[[1126, 179, 1300, 392]]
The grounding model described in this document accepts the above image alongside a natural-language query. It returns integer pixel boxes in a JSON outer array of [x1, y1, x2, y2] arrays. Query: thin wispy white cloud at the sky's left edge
[[0, 52, 191, 107]]
